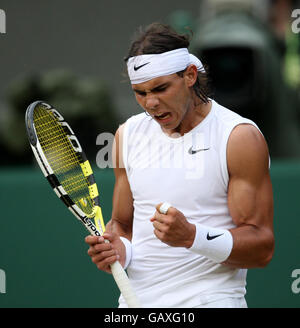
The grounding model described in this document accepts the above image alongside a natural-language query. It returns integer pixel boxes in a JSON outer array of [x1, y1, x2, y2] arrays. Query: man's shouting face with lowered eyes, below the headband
[[132, 68, 195, 132]]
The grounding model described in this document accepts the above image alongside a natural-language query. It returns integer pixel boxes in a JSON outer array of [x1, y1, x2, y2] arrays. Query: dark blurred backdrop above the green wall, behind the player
[[0, 0, 300, 165]]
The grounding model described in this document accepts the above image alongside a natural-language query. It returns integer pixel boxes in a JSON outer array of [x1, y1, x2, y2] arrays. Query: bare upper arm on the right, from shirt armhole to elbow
[[227, 125, 273, 229]]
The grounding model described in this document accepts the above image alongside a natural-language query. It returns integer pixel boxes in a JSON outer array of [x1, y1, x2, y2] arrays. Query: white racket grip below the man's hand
[[110, 261, 141, 308]]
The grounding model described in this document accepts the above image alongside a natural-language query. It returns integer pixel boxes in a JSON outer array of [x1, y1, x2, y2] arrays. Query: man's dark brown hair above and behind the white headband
[[124, 23, 211, 103]]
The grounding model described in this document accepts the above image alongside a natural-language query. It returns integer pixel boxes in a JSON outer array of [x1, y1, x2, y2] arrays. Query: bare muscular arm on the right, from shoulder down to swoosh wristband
[[225, 125, 274, 268]]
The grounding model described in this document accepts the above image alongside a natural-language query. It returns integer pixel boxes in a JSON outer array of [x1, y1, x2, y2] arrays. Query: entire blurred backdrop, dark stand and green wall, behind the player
[[0, 0, 300, 307]]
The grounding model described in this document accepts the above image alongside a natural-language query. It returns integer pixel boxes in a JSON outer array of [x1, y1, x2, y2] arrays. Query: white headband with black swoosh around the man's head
[[127, 48, 205, 84]]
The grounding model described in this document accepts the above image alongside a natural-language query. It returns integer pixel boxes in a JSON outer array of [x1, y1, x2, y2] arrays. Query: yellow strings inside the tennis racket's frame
[[34, 107, 95, 215]]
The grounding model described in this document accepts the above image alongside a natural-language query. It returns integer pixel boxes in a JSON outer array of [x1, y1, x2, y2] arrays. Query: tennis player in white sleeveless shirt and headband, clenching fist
[[86, 23, 274, 308]]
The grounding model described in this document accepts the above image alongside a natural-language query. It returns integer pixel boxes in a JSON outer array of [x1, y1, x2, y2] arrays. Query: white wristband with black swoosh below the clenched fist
[[189, 224, 233, 263]]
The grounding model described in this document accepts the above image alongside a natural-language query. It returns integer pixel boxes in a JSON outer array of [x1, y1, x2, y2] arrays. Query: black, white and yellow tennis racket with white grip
[[25, 101, 140, 307]]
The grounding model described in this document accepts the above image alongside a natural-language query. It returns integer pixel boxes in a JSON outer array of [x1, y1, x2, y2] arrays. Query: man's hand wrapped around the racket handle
[[85, 232, 126, 273]]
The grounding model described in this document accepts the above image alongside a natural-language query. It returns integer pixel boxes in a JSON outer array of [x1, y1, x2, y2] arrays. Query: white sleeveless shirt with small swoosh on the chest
[[119, 100, 256, 307]]
